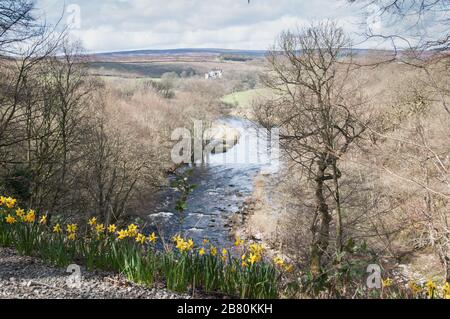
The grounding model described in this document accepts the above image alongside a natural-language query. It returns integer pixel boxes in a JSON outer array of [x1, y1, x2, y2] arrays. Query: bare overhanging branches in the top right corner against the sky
[[348, 0, 450, 114]]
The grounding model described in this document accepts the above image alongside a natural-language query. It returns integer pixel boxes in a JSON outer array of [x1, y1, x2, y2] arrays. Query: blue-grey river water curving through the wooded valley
[[148, 117, 278, 245]]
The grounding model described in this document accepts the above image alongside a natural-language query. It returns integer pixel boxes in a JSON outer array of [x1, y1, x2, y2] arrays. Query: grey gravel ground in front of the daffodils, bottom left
[[0, 248, 190, 299]]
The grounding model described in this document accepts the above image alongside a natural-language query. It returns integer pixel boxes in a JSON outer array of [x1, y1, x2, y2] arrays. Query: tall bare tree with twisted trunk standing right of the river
[[255, 22, 365, 274]]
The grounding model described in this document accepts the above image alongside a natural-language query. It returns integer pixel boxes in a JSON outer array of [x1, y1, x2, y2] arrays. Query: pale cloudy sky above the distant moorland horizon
[[37, 0, 442, 52]]
